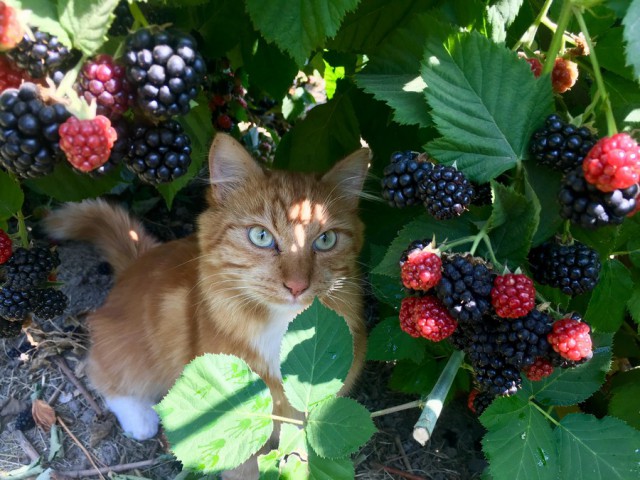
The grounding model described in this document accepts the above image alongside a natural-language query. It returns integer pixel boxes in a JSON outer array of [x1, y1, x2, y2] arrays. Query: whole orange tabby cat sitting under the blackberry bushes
[[44, 133, 370, 474]]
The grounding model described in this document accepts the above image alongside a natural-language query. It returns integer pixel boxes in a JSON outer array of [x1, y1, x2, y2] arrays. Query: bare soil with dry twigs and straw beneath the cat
[[0, 200, 486, 480]]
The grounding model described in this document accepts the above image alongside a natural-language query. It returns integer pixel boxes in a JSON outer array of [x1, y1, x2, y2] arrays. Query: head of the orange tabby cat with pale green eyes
[[200, 133, 368, 308]]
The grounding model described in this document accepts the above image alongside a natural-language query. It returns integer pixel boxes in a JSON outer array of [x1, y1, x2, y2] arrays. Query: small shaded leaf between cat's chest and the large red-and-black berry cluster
[[367, 317, 424, 363]]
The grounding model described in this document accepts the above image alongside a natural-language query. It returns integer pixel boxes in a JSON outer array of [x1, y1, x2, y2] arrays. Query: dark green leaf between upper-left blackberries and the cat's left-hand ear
[[157, 95, 213, 209]]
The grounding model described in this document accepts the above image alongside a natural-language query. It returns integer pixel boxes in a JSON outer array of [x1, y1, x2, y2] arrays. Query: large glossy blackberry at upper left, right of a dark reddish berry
[[123, 28, 206, 120]]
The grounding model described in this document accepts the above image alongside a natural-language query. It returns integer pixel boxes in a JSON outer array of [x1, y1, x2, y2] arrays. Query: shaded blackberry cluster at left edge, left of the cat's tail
[[0, 230, 68, 336]]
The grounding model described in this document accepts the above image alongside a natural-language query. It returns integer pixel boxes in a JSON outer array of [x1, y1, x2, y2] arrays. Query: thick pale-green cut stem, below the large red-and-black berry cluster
[[413, 350, 464, 445]]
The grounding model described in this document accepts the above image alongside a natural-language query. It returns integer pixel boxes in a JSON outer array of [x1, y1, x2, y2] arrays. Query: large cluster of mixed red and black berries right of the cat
[[399, 240, 592, 411]]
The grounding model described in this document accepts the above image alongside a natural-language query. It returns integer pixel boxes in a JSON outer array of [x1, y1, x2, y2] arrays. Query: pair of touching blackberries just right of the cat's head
[[381, 151, 475, 220]]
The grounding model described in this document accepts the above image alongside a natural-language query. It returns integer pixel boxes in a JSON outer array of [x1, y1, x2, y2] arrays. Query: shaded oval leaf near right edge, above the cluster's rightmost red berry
[[584, 258, 633, 332]]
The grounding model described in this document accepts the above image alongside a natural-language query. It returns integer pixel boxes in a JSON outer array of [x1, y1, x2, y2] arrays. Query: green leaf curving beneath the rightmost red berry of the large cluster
[[522, 334, 612, 405]]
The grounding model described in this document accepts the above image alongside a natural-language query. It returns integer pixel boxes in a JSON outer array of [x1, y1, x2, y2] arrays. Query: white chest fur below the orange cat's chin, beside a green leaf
[[252, 305, 303, 378]]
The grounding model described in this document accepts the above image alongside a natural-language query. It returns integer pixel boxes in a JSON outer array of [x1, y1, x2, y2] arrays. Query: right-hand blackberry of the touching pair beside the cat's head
[[417, 165, 475, 220]]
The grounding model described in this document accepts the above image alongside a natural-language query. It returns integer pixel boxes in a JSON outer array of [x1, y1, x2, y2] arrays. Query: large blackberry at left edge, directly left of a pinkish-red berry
[[0, 83, 70, 178]]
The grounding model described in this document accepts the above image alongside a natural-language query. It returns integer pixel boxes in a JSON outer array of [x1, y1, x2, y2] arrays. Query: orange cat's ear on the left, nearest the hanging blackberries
[[209, 133, 264, 202]]
